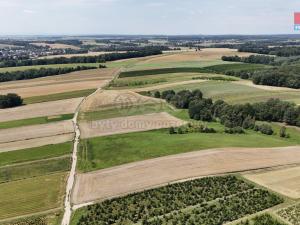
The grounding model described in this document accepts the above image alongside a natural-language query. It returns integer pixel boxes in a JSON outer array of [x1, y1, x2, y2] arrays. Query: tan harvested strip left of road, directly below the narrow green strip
[[0, 120, 74, 143]]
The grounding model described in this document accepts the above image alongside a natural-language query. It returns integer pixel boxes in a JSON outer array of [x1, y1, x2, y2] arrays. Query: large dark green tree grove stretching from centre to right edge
[[154, 89, 300, 129]]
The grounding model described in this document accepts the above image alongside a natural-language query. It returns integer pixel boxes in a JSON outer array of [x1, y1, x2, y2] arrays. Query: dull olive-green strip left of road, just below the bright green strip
[[0, 156, 71, 183]]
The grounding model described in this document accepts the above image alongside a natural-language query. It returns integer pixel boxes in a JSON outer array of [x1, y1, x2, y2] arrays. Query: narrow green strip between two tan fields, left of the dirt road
[[0, 114, 74, 129]]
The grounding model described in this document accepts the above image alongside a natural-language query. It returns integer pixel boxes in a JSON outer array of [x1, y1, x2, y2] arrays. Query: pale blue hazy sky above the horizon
[[0, 0, 300, 35]]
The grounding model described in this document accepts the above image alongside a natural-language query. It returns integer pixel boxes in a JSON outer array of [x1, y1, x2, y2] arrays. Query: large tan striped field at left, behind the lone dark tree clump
[[0, 69, 117, 98]]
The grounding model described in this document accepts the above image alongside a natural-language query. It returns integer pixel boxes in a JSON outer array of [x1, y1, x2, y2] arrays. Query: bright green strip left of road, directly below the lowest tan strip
[[0, 142, 73, 166]]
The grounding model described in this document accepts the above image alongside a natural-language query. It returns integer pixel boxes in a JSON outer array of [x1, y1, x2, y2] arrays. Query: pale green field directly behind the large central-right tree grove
[[150, 81, 300, 104]]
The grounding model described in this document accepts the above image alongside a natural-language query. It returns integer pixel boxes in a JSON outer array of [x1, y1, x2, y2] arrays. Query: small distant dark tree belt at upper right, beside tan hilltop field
[[222, 55, 275, 65]]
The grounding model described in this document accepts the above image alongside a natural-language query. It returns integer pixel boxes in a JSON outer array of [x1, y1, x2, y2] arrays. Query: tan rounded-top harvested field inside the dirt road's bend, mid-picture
[[81, 90, 161, 112]]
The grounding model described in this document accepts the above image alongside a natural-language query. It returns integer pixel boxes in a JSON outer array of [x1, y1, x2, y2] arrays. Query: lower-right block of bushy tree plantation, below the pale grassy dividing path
[[142, 189, 282, 225]]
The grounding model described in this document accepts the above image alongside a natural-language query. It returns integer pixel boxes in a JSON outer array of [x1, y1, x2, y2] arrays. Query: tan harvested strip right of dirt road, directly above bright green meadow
[[79, 112, 185, 138]]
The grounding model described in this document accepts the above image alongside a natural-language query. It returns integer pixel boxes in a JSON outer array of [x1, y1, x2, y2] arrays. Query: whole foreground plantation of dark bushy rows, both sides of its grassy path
[[77, 176, 282, 225]]
